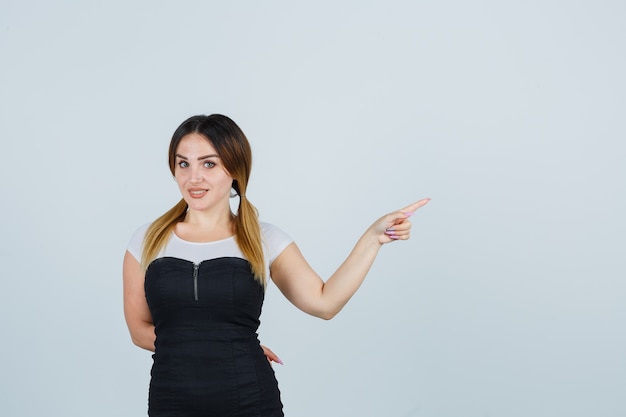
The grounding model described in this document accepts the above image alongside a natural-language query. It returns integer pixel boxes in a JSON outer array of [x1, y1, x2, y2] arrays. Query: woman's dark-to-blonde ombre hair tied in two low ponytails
[[141, 114, 267, 287]]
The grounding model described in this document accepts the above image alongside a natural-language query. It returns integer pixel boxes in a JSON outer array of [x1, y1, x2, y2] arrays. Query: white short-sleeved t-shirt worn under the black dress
[[127, 222, 293, 276]]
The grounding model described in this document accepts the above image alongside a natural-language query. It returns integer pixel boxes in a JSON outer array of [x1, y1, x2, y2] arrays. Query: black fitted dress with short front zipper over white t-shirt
[[145, 257, 284, 417]]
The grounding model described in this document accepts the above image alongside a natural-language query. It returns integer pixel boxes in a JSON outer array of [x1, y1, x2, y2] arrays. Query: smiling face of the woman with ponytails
[[174, 133, 233, 211]]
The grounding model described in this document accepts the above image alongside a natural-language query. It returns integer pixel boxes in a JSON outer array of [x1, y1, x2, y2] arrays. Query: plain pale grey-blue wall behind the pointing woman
[[0, 0, 626, 417]]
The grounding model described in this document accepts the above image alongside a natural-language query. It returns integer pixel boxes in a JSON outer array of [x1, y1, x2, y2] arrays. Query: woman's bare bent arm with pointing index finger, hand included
[[270, 198, 430, 320]]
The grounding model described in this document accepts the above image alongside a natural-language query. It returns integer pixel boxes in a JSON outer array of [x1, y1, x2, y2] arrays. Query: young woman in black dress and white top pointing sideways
[[123, 114, 429, 417]]
